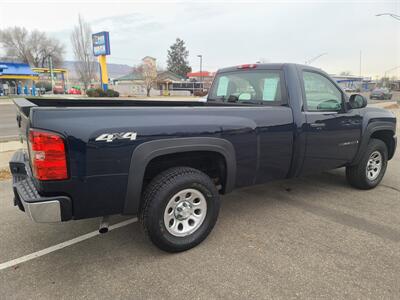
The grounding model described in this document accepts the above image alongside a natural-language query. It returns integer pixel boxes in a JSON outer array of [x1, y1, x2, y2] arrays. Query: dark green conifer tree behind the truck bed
[[167, 38, 192, 77]]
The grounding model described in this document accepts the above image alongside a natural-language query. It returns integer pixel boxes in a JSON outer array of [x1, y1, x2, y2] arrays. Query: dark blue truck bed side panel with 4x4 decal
[[11, 98, 293, 219]]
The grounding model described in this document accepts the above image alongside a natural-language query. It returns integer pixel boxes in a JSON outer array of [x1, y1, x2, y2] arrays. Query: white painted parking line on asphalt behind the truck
[[0, 218, 137, 271]]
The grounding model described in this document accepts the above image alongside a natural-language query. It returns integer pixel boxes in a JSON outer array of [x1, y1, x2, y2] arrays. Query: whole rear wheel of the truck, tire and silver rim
[[140, 167, 220, 252]]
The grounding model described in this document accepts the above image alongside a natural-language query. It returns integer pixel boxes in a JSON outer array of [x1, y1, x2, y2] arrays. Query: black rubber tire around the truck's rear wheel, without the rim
[[140, 167, 220, 252]]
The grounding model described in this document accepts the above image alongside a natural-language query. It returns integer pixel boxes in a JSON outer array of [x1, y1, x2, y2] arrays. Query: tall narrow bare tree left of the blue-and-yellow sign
[[71, 15, 97, 89]]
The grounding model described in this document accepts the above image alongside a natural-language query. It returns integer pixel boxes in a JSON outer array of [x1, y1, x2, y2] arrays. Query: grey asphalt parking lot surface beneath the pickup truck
[[0, 145, 400, 299]]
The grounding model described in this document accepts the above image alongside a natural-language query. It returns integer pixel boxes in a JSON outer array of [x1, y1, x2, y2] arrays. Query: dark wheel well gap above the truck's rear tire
[[142, 151, 227, 193]]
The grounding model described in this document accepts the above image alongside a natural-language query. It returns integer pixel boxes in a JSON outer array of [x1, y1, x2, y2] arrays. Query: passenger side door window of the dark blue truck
[[303, 71, 342, 111]]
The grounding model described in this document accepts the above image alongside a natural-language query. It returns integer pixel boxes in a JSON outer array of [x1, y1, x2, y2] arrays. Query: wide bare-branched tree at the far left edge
[[0, 26, 65, 68]]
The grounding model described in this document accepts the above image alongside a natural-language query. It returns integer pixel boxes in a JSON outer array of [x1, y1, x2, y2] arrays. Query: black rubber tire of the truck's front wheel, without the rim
[[346, 139, 388, 190]]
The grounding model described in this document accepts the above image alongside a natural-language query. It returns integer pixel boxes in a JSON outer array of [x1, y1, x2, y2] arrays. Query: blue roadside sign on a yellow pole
[[92, 31, 111, 91]]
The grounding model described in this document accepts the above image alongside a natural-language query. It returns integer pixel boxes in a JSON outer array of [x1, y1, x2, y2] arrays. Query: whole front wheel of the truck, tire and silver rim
[[346, 139, 388, 190]]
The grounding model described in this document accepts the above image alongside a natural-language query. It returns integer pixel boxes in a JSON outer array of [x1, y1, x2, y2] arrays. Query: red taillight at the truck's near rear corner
[[29, 129, 68, 180]]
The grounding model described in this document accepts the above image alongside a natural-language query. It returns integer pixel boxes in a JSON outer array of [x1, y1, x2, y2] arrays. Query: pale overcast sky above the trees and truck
[[0, 0, 400, 78]]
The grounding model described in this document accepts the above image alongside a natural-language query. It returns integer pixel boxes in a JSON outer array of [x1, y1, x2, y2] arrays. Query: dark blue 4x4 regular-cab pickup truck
[[10, 64, 396, 252]]
